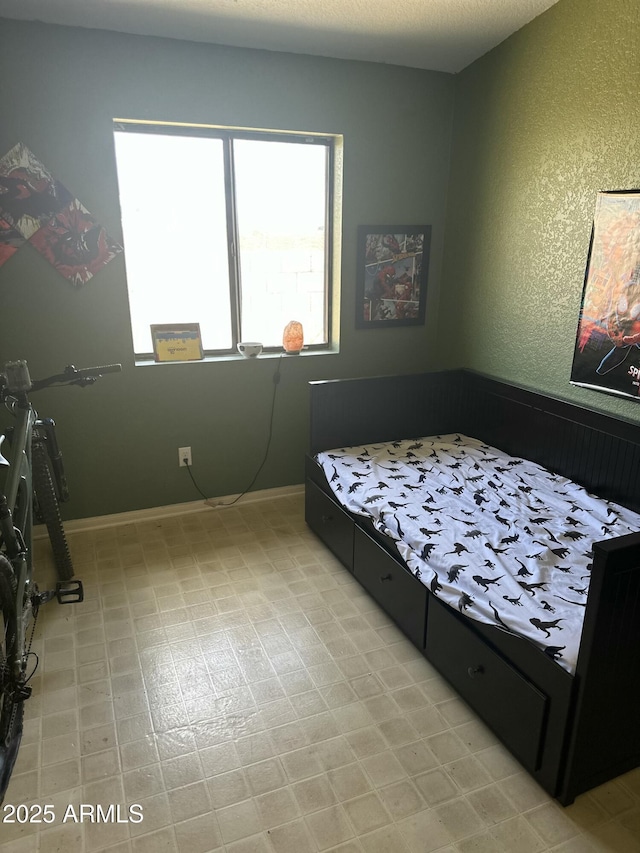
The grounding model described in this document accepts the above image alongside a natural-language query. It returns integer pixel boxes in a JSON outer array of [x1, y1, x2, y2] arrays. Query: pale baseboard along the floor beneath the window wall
[[33, 485, 304, 539]]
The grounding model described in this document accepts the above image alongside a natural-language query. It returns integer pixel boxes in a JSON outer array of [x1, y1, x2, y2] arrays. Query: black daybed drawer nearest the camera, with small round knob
[[426, 597, 548, 771]]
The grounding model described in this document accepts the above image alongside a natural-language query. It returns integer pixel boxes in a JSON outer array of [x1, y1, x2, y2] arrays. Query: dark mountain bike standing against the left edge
[[0, 361, 122, 804]]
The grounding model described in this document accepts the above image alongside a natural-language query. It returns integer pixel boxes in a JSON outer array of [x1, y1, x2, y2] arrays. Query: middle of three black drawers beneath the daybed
[[353, 527, 428, 649]]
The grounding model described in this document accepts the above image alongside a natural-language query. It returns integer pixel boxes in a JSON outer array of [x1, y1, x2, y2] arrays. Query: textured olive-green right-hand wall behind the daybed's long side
[[439, 0, 640, 420]]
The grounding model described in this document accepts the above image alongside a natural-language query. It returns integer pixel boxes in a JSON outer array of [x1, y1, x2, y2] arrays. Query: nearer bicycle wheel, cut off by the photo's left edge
[[0, 555, 24, 804]]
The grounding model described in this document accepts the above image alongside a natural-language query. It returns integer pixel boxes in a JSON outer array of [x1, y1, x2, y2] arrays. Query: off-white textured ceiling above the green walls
[[0, 0, 557, 72]]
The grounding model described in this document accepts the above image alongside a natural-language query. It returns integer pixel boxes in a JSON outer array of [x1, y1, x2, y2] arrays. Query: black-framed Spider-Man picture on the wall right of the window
[[356, 225, 431, 329]]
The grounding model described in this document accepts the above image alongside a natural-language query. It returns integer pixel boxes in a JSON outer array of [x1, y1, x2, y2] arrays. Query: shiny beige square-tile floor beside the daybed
[[0, 495, 640, 853]]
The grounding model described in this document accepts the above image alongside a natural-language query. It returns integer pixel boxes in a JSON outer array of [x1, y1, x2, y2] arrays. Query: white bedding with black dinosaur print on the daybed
[[316, 434, 640, 672]]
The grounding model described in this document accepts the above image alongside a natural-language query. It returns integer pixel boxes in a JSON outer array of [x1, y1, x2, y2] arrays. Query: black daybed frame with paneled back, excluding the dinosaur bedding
[[307, 370, 640, 805]]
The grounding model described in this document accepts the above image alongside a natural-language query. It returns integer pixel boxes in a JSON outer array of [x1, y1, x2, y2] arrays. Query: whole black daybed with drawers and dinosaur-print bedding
[[305, 370, 640, 805]]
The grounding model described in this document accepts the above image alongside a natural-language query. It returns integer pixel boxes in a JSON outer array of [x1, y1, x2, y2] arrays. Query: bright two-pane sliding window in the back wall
[[114, 120, 336, 358]]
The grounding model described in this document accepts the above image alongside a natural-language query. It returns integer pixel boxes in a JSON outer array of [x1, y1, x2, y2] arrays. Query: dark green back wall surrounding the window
[[0, 20, 455, 518]]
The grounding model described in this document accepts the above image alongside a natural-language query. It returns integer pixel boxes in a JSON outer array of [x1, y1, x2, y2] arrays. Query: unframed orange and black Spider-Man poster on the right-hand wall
[[571, 190, 640, 399]]
